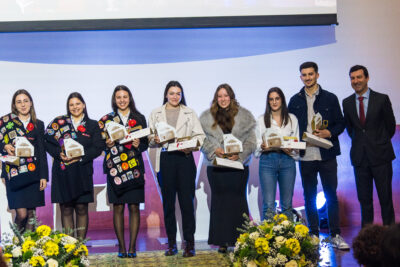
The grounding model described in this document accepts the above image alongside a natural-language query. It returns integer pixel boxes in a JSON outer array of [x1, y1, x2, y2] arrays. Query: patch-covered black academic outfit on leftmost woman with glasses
[[0, 114, 48, 209]]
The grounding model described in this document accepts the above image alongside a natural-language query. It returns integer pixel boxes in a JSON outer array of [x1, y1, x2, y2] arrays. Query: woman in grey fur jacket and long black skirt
[[200, 84, 256, 253]]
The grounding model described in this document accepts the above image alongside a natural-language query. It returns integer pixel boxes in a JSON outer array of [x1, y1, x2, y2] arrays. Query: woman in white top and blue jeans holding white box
[[254, 87, 299, 222]]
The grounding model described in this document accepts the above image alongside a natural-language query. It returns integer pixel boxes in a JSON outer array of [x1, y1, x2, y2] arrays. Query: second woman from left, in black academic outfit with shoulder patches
[[45, 92, 104, 239]]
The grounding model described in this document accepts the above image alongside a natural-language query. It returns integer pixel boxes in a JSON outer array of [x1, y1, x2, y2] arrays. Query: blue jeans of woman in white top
[[259, 152, 296, 220]]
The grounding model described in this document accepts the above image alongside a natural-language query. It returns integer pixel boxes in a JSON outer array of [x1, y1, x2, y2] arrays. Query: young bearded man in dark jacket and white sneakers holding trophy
[[289, 62, 349, 250]]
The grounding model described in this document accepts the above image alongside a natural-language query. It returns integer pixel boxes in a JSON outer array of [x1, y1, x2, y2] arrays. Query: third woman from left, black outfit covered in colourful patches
[[99, 85, 148, 258]]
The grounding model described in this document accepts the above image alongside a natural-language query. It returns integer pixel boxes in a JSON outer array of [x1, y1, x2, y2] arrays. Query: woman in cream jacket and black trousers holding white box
[[149, 81, 205, 257]]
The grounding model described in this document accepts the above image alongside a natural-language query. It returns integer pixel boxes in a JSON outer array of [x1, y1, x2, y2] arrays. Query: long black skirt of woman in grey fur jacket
[[207, 166, 249, 246]]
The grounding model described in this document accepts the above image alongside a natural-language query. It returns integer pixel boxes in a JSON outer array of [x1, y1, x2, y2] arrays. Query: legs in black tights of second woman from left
[[60, 203, 89, 240]]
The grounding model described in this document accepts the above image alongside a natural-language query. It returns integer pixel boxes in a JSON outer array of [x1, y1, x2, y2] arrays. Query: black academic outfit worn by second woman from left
[[45, 116, 104, 203]]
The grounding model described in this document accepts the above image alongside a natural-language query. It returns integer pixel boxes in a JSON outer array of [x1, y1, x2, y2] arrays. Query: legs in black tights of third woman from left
[[114, 204, 140, 253]]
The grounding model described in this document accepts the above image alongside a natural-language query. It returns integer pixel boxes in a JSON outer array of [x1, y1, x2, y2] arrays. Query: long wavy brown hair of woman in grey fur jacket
[[210, 83, 239, 132]]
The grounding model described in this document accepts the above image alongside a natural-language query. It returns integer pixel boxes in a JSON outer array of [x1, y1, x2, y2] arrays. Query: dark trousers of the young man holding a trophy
[[299, 157, 340, 236]]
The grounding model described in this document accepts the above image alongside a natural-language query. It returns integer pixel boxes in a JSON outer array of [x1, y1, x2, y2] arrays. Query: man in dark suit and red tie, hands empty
[[343, 65, 396, 227]]
